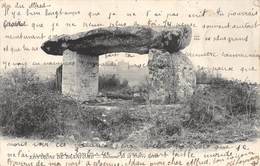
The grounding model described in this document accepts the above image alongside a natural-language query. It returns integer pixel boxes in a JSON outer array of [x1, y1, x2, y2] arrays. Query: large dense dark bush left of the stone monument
[[0, 68, 77, 138]]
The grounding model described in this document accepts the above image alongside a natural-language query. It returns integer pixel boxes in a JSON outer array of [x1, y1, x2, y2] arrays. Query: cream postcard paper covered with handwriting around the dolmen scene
[[0, 0, 260, 166]]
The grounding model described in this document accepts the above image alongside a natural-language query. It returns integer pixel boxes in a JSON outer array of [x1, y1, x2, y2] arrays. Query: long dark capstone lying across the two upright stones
[[41, 26, 191, 56]]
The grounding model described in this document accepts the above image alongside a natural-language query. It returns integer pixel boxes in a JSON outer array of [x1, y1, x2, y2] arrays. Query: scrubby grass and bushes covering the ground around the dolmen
[[0, 70, 260, 148]]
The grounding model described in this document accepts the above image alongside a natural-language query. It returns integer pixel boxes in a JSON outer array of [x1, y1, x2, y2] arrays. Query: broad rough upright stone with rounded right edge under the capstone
[[148, 49, 196, 104]]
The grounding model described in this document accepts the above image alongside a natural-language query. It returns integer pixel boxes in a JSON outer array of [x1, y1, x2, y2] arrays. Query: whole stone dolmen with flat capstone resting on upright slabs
[[41, 26, 195, 102]]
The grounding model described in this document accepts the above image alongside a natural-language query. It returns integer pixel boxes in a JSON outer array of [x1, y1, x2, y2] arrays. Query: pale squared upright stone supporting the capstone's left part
[[62, 50, 99, 100]]
